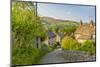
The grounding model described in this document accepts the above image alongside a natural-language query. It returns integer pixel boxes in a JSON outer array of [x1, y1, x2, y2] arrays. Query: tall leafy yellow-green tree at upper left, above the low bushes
[[12, 2, 46, 47]]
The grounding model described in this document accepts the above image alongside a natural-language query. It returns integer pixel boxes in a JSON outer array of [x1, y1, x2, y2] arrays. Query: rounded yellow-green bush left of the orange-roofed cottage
[[61, 36, 80, 50]]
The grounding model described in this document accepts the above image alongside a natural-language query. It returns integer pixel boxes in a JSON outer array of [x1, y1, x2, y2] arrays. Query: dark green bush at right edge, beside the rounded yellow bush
[[79, 40, 96, 55]]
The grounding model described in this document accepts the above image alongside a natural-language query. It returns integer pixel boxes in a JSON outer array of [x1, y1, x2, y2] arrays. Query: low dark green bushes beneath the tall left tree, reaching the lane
[[12, 45, 50, 65]]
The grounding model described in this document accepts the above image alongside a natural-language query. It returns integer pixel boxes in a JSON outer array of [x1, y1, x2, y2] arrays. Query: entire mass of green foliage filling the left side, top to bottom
[[12, 1, 48, 65]]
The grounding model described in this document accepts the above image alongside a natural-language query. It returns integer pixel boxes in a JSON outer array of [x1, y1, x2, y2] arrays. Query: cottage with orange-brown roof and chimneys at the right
[[74, 20, 95, 43]]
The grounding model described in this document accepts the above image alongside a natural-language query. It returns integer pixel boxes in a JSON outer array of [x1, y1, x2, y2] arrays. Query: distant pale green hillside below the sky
[[41, 17, 79, 27]]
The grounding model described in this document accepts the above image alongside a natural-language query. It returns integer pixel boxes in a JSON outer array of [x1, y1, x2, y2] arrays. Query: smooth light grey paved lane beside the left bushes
[[41, 49, 66, 63]]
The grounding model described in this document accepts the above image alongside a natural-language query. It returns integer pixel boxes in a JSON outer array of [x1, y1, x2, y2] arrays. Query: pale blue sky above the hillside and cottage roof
[[37, 3, 95, 22]]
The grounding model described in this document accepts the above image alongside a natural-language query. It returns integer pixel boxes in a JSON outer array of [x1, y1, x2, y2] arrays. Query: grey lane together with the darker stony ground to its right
[[41, 48, 95, 64]]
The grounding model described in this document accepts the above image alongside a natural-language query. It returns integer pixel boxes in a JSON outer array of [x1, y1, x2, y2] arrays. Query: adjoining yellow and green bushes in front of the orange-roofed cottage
[[61, 36, 96, 55]]
